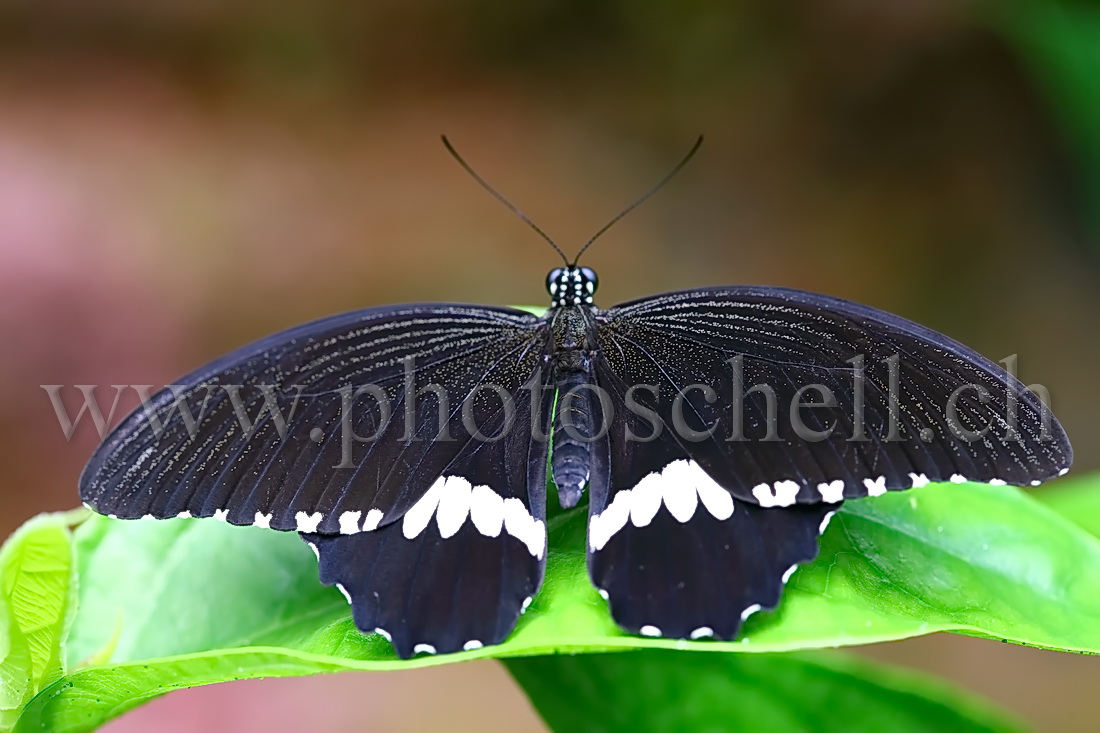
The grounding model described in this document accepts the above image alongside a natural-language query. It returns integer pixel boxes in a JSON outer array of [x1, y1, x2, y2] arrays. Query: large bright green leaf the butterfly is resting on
[[8, 477, 1100, 731]]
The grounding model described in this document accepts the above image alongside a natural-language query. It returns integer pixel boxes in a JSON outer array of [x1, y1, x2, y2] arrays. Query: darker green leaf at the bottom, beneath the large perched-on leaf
[[505, 649, 1023, 733]]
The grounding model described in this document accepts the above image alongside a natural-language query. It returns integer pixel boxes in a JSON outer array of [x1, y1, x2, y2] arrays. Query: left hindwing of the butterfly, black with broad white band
[[303, 376, 553, 657]]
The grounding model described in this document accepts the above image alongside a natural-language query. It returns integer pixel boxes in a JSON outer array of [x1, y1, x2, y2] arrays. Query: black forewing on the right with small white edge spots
[[598, 287, 1073, 506]]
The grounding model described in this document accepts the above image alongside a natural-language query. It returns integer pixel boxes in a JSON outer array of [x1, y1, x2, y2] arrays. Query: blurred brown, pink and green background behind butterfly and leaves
[[0, 0, 1100, 733]]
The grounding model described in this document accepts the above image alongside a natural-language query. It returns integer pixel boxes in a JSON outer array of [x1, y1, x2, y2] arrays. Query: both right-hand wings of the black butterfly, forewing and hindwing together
[[589, 287, 1071, 638]]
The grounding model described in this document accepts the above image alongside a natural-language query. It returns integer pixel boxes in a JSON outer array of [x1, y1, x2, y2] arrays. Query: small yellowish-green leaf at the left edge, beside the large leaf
[[0, 514, 74, 731]]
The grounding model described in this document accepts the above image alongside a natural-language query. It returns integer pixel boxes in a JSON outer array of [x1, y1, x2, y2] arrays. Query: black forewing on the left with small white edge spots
[[80, 304, 547, 534]]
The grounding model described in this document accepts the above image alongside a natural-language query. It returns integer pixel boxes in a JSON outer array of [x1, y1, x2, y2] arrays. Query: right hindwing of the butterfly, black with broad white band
[[587, 364, 838, 639]]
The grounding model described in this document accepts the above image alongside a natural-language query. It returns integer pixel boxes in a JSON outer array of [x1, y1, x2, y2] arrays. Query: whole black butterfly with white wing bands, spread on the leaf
[[80, 139, 1071, 657]]
